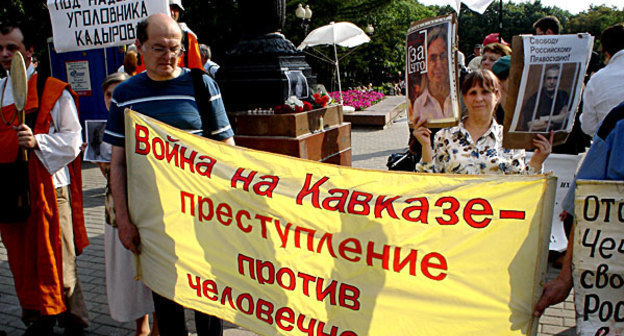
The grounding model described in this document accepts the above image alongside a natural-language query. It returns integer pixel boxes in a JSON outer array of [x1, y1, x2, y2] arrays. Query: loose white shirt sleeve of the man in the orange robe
[[34, 90, 82, 174]]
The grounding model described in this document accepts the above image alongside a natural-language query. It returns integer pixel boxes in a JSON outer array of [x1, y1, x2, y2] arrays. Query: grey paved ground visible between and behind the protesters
[[0, 99, 575, 336]]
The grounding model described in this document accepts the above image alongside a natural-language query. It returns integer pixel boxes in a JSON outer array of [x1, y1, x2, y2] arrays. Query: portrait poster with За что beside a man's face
[[405, 13, 461, 128]]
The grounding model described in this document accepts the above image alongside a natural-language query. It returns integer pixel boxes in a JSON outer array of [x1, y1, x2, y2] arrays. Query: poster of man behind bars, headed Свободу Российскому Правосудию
[[504, 34, 594, 149]]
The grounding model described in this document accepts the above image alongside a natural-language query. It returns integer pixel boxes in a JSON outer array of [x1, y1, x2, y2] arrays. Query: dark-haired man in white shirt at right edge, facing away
[[580, 23, 624, 137]]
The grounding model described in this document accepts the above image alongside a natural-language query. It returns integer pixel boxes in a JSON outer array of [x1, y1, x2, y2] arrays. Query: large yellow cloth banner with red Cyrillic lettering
[[126, 111, 555, 336]]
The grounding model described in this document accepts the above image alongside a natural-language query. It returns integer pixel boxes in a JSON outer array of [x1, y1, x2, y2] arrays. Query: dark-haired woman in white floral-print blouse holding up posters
[[413, 70, 553, 175]]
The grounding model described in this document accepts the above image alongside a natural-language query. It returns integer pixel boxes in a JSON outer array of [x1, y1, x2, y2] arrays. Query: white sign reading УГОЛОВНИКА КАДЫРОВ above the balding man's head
[[47, 0, 169, 52]]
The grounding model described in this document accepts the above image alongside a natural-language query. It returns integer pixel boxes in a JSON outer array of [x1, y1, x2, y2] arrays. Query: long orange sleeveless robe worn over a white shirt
[[0, 74, 89, 315]]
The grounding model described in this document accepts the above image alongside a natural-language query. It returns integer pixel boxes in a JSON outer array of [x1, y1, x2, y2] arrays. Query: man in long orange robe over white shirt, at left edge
[[0, 24, 88, 335]]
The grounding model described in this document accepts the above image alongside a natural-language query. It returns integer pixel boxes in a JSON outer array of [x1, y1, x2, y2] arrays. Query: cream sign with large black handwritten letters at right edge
[[572, 180, 624, 336]]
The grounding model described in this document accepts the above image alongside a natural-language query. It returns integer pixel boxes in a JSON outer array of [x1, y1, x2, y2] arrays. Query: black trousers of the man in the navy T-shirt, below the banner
[[152, 292, 223, 336]]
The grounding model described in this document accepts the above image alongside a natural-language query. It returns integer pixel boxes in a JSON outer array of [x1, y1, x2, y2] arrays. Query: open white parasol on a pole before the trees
[[297, 22, 370, 104]]
